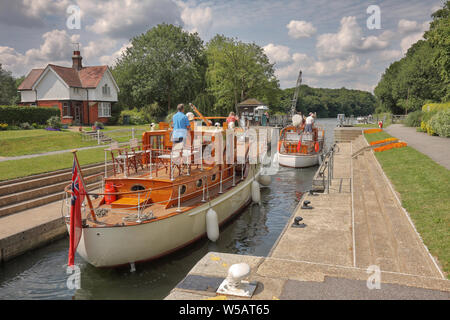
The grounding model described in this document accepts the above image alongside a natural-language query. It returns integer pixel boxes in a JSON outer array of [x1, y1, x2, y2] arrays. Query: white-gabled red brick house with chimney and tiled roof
[[18, 51, 119, 125]]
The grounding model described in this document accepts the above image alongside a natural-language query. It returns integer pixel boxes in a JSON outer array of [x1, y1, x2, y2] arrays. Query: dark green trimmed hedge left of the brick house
[[0, 106, 61, 125]]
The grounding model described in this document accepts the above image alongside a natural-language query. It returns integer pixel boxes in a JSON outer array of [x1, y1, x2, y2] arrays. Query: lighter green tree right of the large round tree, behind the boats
[[206, 35, 280, 114]]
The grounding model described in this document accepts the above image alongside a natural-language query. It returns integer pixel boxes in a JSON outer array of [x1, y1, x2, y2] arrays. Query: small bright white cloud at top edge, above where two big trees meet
[[177, 1, 212, 34]]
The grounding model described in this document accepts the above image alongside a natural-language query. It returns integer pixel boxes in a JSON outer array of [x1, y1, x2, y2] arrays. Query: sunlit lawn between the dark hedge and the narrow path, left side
[[0, 129, 97, 157]]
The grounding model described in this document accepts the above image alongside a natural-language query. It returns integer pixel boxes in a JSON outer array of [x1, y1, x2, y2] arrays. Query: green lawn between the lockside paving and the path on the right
[[365, 132, 450, 279]]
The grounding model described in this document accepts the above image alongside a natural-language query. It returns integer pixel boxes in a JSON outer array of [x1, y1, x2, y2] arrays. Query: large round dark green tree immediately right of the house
[[113, 24, 206, 113]]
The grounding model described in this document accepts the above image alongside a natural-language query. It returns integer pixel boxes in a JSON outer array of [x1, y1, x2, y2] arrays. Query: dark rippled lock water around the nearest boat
[[0, 119, 336, 299]]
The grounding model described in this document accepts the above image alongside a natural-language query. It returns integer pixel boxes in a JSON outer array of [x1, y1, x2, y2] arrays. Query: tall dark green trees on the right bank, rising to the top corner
[[374, 1, 450, 114]]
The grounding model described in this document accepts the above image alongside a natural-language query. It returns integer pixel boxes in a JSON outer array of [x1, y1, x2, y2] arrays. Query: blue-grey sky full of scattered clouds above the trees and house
[[0, 0, 443, 91]]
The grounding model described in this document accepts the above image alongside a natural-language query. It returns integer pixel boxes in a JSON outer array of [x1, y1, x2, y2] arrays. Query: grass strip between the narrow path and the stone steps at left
[[0, 146, 109, 181]]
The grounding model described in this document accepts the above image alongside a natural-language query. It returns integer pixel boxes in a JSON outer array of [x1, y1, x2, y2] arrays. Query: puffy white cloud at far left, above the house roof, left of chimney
[[0, 30, 79, 75]]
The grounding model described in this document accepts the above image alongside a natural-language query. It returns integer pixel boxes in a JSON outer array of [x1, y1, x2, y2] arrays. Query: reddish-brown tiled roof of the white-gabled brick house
[[18, 64, 108, 90]]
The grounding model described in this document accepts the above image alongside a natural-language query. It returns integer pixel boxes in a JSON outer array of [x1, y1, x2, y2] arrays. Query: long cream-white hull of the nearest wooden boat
[[67, 166, 254, 267]]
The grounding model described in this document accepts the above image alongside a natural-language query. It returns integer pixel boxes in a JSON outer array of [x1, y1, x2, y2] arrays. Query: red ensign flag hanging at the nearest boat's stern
[[68, 159, 85, 266]]
